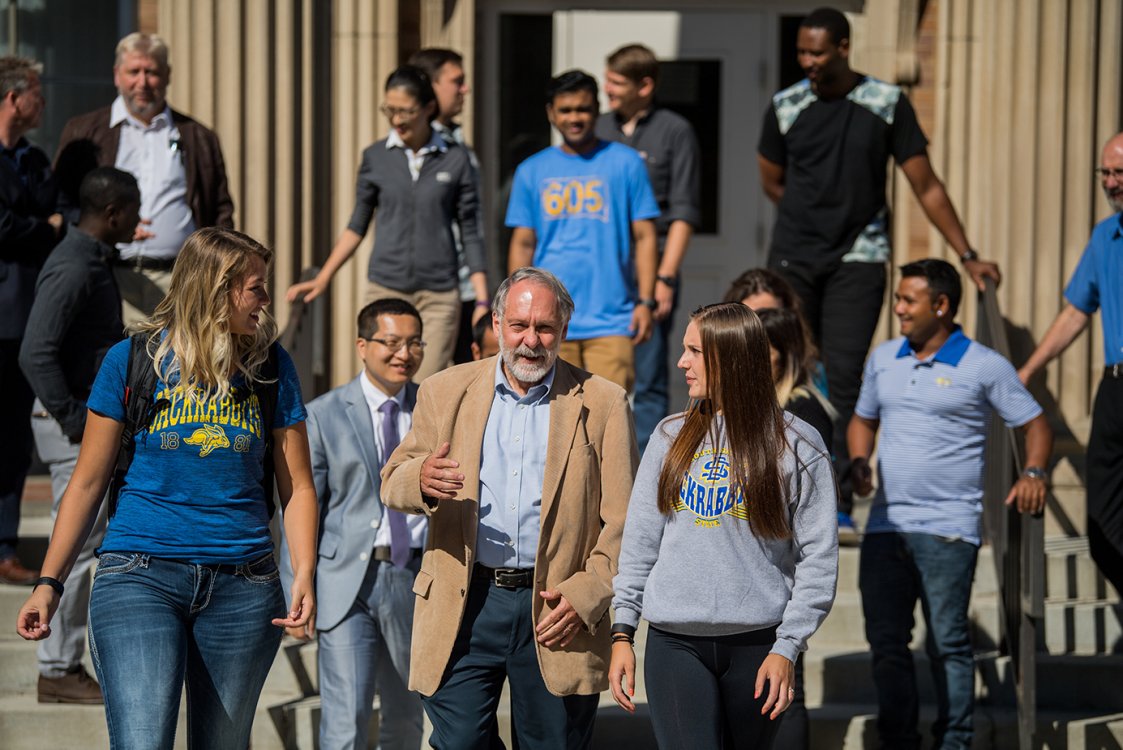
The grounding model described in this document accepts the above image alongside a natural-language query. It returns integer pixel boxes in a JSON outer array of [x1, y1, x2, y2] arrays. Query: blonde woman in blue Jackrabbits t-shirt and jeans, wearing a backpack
[[17, 228, 318, 750]]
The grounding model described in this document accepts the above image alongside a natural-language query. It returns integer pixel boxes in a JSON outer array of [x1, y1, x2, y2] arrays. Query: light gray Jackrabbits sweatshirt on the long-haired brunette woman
[[612, 414, 838, 661]]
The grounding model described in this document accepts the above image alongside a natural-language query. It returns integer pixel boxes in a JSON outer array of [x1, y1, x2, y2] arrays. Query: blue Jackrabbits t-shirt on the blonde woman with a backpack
[[86, 339, 307, 565]]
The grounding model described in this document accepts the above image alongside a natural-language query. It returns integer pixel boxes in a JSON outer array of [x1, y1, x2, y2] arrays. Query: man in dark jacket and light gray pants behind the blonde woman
[[19, 166, 140, 703]]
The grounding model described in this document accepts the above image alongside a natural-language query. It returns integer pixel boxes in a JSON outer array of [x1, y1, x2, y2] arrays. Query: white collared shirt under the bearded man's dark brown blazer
[[109, 97, 195, 259]]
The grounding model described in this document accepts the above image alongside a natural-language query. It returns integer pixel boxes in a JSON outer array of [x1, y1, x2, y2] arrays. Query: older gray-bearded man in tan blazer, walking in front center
[[382, 268, 637, 749]]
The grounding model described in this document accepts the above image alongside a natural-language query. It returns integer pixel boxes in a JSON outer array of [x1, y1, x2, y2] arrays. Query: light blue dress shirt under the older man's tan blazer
[[476, 357, 557, 568]]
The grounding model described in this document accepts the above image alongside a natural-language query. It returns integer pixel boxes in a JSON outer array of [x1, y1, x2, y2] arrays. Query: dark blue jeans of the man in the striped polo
[[858, 532, 978, 750]]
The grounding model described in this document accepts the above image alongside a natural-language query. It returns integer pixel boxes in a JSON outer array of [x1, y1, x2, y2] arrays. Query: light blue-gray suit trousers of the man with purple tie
[[319, 557, 424, 750]]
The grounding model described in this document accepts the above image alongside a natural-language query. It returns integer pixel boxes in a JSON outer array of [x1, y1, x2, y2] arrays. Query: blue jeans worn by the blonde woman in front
[[90, 552, 285, 750]]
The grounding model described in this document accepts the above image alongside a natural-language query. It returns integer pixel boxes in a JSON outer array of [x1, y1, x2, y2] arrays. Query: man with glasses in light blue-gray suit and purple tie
[[282, 299, 427, 750]]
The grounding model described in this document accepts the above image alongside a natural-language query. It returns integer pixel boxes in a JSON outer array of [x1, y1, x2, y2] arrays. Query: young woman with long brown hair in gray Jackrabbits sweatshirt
[[609, 302, 838, 750]]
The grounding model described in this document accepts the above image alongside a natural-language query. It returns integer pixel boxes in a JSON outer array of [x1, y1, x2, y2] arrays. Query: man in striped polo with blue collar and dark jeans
[[847, 258, 1052, 749]]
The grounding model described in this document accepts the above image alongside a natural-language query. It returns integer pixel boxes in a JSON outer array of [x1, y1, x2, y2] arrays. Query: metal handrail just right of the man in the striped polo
[[976, 280, 1046, 750]]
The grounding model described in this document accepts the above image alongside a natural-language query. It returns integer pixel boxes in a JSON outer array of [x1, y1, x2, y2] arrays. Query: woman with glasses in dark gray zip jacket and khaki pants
[[286, 65, 490, 381]]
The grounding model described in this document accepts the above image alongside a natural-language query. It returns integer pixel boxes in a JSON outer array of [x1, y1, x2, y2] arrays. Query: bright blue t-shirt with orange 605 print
[[506, 140, 659, 340]]
